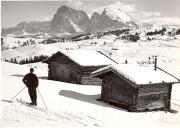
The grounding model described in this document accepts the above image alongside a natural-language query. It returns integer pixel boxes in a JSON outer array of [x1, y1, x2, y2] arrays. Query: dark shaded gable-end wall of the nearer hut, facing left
[[102, 73, 136, 104]]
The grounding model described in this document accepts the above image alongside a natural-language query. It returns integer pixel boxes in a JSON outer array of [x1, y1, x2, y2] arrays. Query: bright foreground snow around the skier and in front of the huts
[[0, 62, 180, 128]]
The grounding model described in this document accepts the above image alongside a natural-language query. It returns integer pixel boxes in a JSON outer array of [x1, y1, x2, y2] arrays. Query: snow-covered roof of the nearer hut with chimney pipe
[[91, 64, 179, 85]]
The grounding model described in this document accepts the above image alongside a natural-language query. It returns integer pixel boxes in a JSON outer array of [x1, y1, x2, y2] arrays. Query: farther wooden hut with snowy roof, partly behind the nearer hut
[[44, 50, 115, 85]]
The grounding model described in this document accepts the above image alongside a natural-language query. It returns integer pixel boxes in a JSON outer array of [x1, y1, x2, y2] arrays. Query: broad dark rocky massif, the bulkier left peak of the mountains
[[51, 5, 89, 34]]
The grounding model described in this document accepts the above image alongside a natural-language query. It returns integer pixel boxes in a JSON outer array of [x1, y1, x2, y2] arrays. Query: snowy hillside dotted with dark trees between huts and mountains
[[1, 27, 180, 66]]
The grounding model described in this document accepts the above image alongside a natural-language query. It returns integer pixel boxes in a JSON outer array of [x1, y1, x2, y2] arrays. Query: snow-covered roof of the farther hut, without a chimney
[[45, 50, 115, 66]]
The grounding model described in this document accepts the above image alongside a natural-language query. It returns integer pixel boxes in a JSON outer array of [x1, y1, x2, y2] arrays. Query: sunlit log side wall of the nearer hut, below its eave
[[136, 84, 171, 110]]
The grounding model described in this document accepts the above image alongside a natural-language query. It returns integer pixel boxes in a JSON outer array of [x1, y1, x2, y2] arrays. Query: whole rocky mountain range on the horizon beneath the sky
[[1, 5, 138, 37]]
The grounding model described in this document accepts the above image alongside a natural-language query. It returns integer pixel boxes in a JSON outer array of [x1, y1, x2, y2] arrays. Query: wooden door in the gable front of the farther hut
[[58, 64, 70, 82]]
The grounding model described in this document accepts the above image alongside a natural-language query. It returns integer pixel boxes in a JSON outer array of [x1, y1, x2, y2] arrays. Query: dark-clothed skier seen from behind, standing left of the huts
[[23, 68, 39, 106]]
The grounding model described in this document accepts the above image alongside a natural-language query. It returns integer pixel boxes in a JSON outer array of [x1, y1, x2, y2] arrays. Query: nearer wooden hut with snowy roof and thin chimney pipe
[[91, 64, 178, 111]]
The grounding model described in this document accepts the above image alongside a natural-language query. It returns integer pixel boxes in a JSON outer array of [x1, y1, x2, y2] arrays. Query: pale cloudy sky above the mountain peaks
[[1, 0, 180, 28]]
